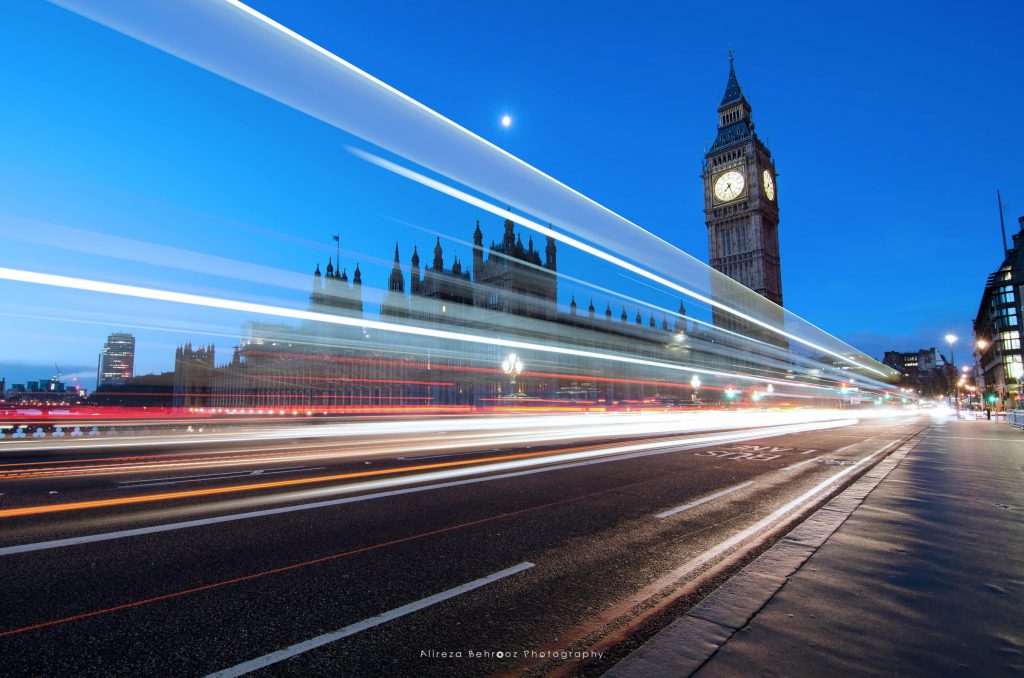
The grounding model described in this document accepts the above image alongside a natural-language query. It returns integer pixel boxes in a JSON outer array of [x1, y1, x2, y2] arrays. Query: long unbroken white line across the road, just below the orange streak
[[0, 419, 857, 557]]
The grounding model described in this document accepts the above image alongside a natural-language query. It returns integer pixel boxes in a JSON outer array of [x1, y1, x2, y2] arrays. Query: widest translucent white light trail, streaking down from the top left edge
[[53, 0, 896, 385]]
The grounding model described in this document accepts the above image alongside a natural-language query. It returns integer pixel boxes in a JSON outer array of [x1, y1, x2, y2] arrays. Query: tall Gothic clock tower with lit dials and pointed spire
[[701, 50, 782, 327]]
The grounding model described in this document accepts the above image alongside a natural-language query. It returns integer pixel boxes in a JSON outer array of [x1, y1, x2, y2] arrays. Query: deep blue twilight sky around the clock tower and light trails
[[0, 0, 1024, 379]]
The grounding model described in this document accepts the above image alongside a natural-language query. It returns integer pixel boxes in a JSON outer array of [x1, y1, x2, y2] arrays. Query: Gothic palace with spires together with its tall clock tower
[[174, 55, 788, 412]]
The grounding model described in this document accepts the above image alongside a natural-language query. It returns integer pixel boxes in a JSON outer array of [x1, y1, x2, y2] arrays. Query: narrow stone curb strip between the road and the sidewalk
[[603, 435, 918, 678]]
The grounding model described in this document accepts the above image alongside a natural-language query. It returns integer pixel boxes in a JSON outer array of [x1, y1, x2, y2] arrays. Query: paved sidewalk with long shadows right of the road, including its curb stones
[[609, 420, 1024, 677]]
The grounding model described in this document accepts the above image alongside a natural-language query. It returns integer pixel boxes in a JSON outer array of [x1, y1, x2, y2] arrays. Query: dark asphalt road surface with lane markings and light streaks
[[0, 417, 929, 676]]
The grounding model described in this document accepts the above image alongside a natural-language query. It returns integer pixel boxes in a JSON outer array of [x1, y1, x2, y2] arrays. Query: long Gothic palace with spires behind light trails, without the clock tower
[[175, 220, 708, 412]]
